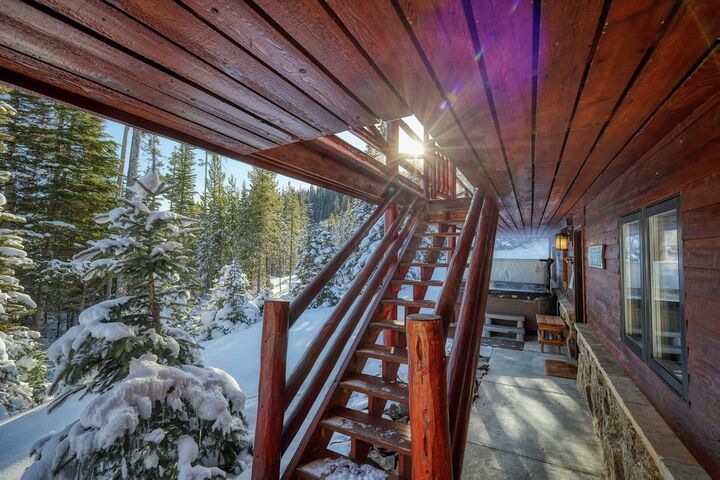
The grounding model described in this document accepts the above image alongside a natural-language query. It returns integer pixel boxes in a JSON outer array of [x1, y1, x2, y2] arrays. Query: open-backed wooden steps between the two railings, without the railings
[[294, 216, 462, 479]]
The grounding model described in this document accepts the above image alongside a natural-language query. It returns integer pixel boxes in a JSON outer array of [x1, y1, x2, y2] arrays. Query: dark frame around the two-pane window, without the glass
[[618, 196, 688, 400]]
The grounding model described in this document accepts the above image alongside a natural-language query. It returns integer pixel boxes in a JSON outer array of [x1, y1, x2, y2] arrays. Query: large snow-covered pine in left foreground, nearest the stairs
[[23, 172, 250, 480]]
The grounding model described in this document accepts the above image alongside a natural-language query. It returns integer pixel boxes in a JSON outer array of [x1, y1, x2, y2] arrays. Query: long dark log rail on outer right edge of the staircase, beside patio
[[447, 199, 498, 478]]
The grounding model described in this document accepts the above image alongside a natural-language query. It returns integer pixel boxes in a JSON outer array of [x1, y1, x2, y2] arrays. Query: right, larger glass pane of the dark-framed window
[[648, 209, 682, 380]]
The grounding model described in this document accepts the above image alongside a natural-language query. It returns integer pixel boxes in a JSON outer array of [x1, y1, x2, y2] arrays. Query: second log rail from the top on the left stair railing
[[285, 199, 417, 408]]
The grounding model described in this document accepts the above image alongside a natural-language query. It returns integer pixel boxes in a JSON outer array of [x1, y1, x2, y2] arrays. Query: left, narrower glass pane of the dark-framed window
[[622, 220, 643, 345]]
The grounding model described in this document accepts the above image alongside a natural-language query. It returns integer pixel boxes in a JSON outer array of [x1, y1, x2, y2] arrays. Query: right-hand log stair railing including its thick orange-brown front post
[[407, 193, 498, 480]]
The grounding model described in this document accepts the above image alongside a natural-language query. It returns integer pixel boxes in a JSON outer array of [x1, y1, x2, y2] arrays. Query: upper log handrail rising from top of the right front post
[[435, 191, 485, 332]]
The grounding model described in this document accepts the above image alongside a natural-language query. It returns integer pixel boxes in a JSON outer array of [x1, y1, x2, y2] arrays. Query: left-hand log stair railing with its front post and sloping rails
[[252, 186, 419, 479]]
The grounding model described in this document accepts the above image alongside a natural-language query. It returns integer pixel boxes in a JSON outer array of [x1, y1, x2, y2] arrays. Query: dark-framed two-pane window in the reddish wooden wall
[[620, 198, 687, 397]]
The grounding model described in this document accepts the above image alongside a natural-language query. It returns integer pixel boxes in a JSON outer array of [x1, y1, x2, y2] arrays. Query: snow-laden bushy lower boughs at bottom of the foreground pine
[[23, 355, 252, 480]]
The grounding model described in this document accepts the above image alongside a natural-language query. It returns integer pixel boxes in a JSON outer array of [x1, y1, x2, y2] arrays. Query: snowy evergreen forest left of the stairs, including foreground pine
[[0, 87, 383, 478]]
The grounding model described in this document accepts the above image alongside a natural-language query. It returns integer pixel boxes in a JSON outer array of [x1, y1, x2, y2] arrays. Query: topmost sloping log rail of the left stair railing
[[290, 190, 400, 326]]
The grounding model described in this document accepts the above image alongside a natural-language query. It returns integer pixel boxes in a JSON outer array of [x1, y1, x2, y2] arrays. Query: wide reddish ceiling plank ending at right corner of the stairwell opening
[[253, 0, 410, 123]]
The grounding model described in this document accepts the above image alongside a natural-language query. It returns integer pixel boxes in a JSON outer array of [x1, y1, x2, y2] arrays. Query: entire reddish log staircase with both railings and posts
[[252, 192, 498, 480]]
